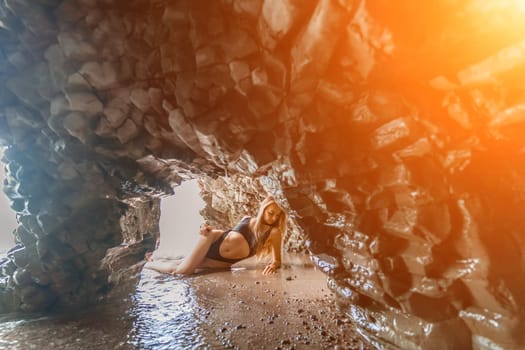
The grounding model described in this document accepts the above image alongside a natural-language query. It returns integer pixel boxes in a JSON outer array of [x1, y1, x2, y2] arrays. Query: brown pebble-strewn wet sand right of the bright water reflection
[[188, 254, 372, 349]]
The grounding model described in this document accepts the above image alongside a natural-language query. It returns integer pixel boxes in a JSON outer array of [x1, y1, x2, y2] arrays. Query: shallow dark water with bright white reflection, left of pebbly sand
[[0, 270, 213, 350]]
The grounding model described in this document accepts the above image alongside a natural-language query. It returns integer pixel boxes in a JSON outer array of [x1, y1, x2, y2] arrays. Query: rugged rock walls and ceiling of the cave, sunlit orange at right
[[0, 0, 525, 349]]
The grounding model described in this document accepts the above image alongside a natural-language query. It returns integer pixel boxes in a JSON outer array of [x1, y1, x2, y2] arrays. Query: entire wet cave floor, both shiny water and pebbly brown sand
[[0, 256, 372, 349]]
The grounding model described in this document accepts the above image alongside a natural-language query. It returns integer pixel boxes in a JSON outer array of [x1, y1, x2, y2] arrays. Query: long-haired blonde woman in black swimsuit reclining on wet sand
[[144, 196, 287, 275]]
